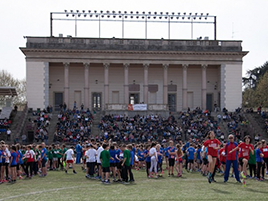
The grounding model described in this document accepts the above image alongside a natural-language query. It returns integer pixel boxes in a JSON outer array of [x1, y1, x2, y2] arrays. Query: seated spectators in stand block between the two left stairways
[[54, 107, 93, 143]]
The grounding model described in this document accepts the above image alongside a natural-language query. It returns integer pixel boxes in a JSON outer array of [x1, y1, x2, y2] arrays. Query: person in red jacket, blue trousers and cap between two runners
[[224, 135, 241, 183]]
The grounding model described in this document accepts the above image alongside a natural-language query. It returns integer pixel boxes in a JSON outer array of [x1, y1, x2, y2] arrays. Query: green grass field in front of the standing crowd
[[0, 167, 268, 201]]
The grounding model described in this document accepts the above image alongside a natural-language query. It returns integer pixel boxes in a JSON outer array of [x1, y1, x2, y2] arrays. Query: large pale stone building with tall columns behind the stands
[[20, 37, 248, 111]]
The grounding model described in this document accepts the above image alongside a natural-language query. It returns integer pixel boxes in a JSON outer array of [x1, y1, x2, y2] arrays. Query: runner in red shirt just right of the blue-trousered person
[[230, 135, 254, 178]]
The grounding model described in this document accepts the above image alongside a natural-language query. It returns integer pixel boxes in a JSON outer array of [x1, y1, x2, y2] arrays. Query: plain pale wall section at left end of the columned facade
[[26, 61, 47, 110]]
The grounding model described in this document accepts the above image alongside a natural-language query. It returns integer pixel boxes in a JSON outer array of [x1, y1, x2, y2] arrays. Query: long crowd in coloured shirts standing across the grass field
[[0, 131, 268, 184]]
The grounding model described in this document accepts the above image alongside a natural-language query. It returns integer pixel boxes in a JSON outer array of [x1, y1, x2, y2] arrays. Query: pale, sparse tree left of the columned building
[[0, 70, 26, 105]]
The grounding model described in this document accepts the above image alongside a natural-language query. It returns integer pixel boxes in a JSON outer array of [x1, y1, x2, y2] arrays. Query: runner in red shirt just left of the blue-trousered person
[[203, 131, 221, 183]]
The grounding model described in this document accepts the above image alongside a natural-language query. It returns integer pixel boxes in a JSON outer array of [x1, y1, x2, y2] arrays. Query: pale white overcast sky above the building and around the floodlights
[[0, 0, 268, 79]]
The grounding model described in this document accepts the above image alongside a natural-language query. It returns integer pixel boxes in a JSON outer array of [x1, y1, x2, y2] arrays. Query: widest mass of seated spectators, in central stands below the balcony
[[98, 108, 226, 143]]
